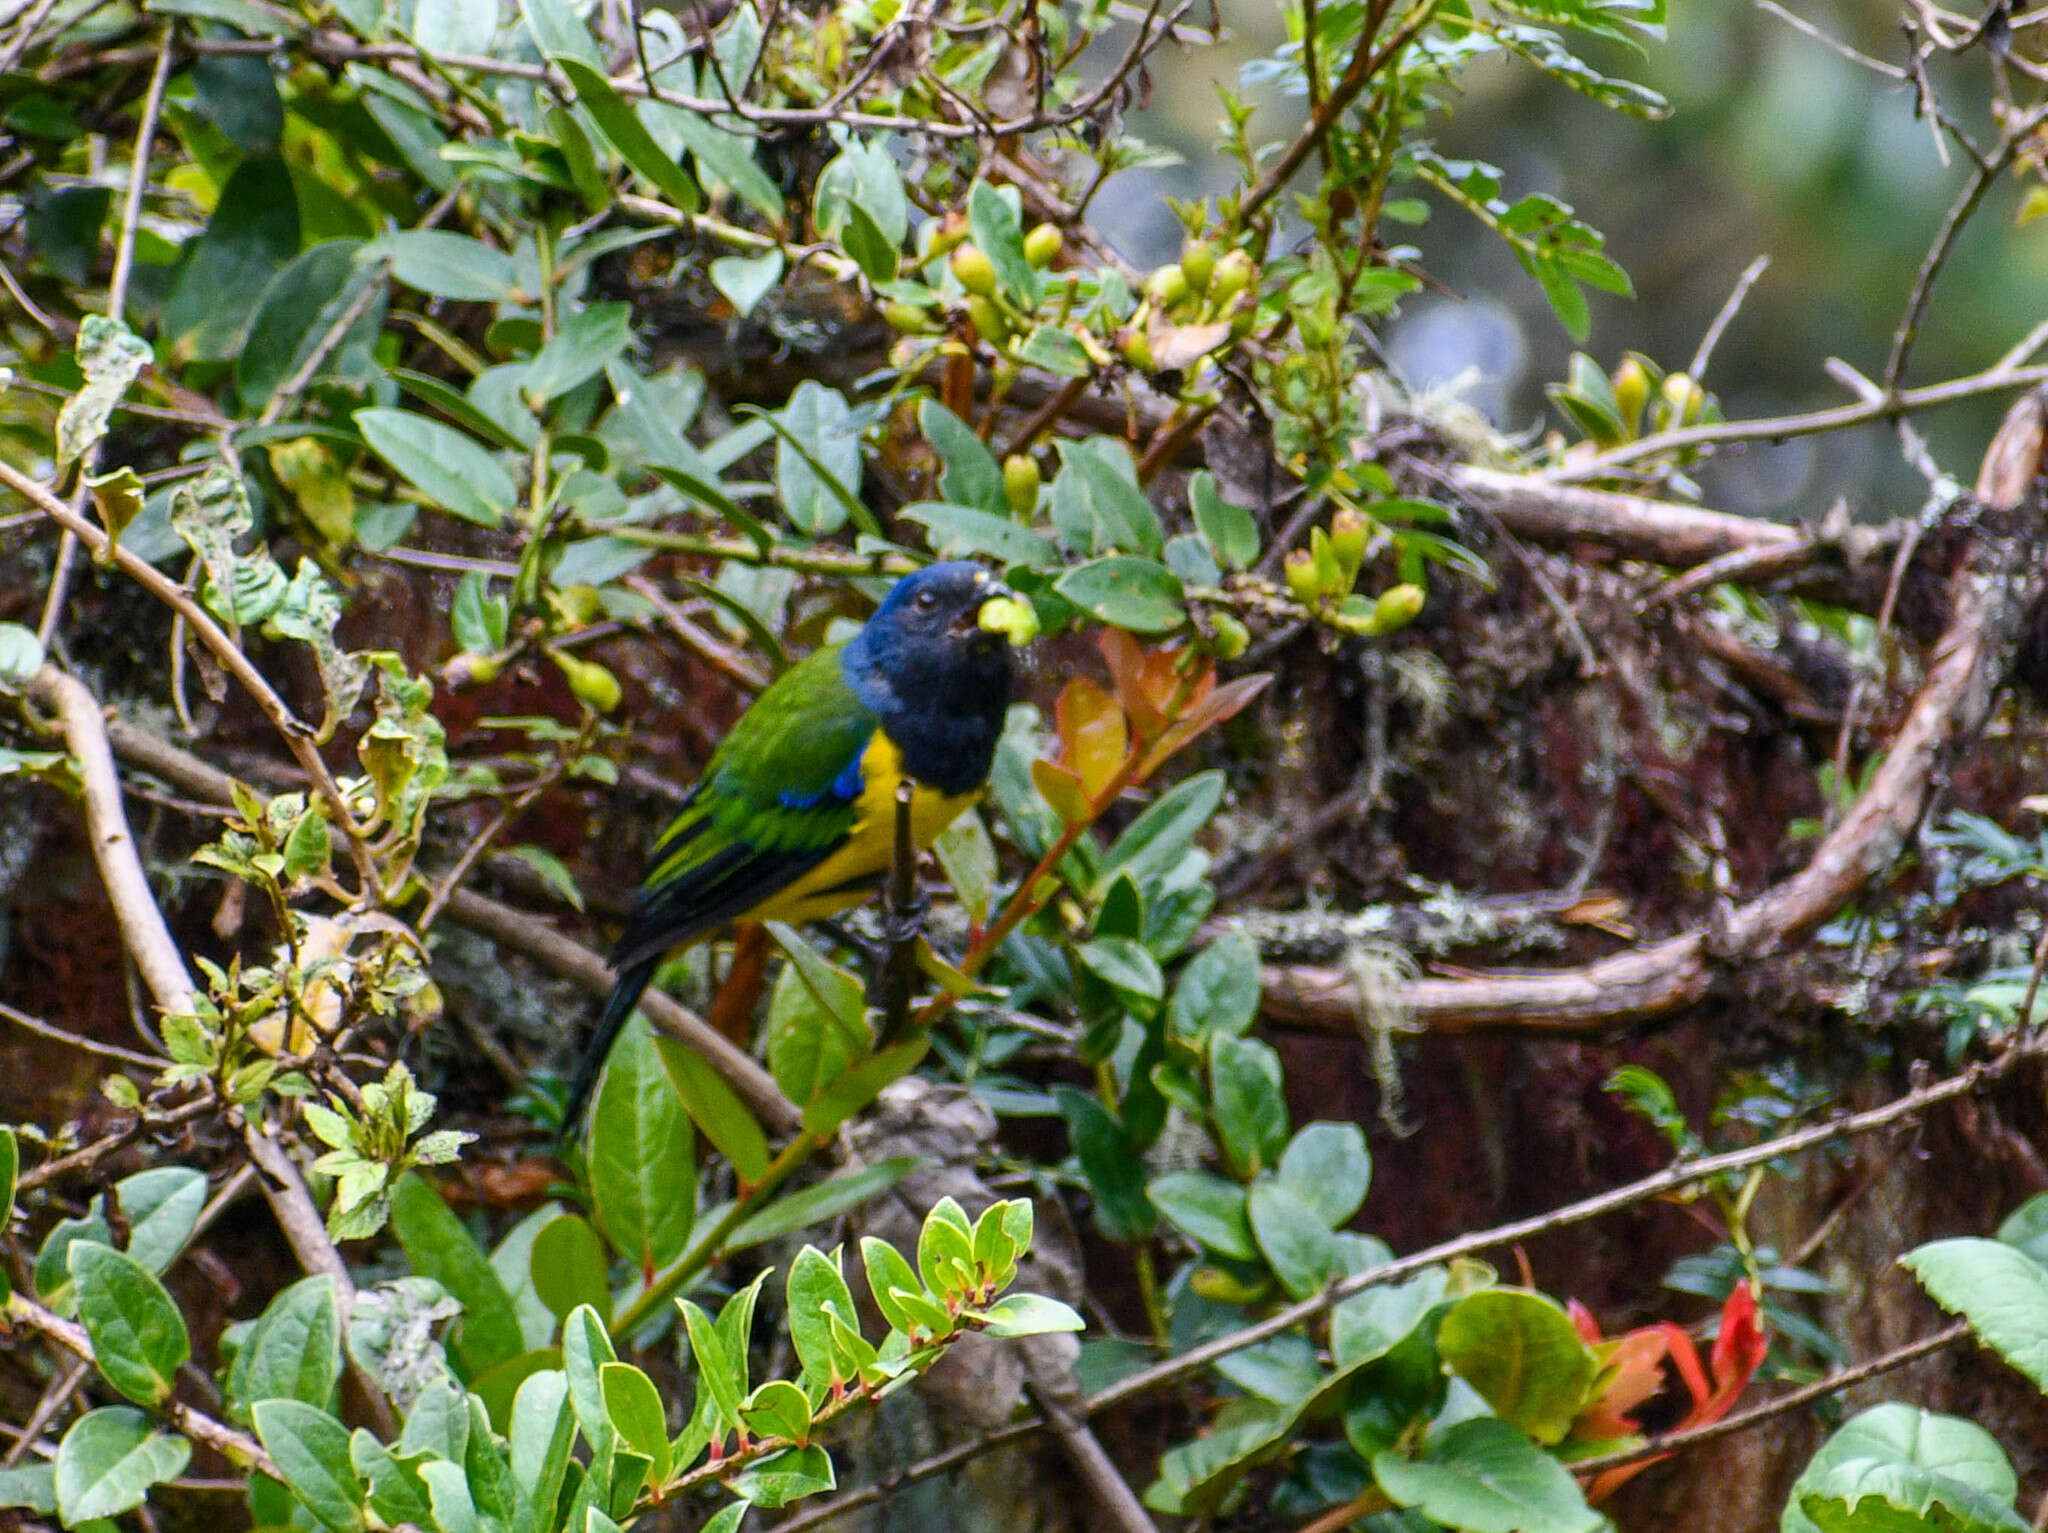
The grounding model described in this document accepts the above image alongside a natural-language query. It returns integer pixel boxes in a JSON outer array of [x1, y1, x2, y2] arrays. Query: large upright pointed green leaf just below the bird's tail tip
[[590, 1015, 696, 1273]]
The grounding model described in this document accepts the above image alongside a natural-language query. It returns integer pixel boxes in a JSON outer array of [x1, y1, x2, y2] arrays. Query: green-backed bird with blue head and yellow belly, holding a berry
[[561, 559, 1028, 1134]]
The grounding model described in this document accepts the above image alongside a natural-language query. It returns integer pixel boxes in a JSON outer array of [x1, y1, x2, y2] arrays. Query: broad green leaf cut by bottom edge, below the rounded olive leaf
[[1372, 1416, 1608, 1533]]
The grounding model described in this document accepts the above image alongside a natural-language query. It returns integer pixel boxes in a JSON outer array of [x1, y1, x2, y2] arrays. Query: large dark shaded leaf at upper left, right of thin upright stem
[[160, 156, 299, 362]]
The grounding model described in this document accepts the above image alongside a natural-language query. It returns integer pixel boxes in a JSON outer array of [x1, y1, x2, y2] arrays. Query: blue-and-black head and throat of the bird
[[844, 561, 1012, 792]]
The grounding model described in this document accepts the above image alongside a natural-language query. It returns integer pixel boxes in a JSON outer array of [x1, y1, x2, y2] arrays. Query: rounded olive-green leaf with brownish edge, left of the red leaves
[[1436, 1287, 1599, 1443]]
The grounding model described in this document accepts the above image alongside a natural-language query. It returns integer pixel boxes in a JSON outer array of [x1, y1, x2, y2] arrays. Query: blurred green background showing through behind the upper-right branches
[[1098, 0, 2048, 520]]
